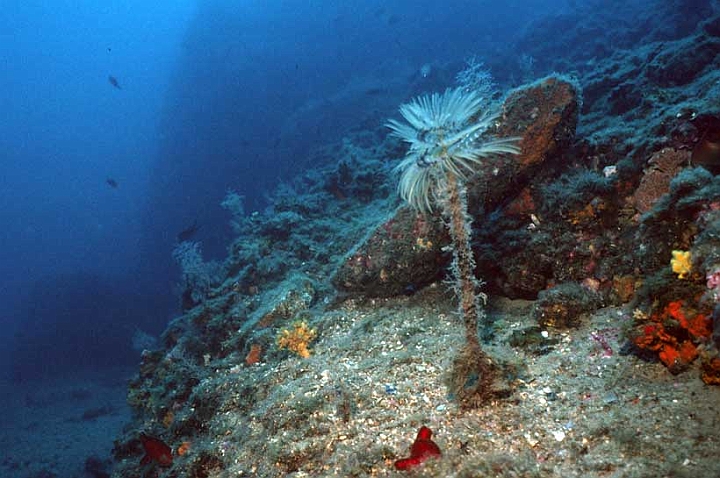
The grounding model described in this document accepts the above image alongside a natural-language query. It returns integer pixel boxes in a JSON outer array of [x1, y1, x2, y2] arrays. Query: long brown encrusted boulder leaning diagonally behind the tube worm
[[333, 77, 578, 297]]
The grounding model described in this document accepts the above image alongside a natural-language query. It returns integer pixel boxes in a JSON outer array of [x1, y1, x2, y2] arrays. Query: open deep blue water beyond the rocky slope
[[0, 0, 565, 379]]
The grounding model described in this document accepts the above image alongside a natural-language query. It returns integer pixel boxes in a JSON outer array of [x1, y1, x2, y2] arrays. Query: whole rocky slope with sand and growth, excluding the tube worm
[[108, 10, 720, 477]]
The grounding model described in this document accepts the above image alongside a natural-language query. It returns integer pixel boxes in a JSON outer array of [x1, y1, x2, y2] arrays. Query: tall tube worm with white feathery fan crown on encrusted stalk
[[387, 88, 520, 405]]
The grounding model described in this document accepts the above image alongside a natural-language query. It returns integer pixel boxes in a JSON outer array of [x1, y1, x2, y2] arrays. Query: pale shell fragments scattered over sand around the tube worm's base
[[228, 292, 720, 477]]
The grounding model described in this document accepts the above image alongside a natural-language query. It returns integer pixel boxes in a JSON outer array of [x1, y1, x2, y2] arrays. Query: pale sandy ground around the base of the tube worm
[[218, 291, 720, 477]]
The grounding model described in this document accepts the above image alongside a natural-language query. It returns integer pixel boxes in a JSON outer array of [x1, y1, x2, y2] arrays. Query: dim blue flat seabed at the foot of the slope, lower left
[[0, 369, 134, 478]]
